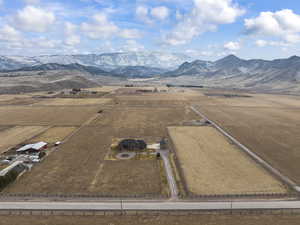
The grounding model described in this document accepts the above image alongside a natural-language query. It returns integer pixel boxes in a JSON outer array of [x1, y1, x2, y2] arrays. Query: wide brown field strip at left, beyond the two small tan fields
[[0, 106, 99, 126]]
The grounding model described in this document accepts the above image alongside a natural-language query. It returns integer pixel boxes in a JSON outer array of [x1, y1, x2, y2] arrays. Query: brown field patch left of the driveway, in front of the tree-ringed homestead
[[89, 160, 162, 195]]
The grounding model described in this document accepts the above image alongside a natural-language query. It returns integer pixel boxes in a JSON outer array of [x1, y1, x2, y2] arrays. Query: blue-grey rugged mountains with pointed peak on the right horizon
[[164, 55, 300, 91]]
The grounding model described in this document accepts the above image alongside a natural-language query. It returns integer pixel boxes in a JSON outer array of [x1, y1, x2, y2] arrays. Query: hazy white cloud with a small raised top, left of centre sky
[[81, 13, 141, 39]]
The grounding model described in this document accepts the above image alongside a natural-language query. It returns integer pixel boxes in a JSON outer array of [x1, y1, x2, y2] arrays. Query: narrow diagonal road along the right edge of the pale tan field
[[191, 106, 300, 192]]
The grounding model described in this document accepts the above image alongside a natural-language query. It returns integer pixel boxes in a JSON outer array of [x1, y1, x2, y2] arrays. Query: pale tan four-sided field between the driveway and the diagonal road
[[168, 127, 286, 195]]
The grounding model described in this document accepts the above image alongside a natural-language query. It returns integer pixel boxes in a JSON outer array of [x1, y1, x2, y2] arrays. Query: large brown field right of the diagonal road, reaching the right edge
[[193, 92, 300, 185]]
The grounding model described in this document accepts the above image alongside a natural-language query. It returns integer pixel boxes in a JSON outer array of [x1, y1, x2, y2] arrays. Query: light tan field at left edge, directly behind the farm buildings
[[0, 126, 48, 153]]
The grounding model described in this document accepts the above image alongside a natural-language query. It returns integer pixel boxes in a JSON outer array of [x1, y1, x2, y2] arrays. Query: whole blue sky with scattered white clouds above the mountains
[[0, 0, 300, 60]]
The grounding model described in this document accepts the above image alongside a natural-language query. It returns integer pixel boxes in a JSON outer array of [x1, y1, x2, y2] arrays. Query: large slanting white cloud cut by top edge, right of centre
[[164, 0, 245, 45]]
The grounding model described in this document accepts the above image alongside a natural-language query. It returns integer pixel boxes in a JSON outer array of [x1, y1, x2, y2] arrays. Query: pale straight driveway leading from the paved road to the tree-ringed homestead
[[159, 150, 178, 200]]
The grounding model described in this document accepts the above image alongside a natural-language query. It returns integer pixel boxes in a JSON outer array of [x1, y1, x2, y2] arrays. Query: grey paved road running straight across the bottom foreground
[[0, 201, 300, 211]]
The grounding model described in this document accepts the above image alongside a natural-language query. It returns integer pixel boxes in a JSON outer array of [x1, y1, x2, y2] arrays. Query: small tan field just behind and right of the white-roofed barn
[[30, 127, 77, 143]]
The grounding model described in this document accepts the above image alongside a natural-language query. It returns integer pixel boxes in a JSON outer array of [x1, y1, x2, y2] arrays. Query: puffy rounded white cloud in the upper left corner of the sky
[[13, 6, 55, 32]]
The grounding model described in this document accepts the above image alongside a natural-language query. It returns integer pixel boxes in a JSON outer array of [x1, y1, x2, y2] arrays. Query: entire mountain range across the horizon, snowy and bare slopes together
[[0, 52, 300, 93]]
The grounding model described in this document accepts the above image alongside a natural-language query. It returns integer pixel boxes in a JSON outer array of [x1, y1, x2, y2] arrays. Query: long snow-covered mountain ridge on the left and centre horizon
[[0, 52, 191, 71]]
